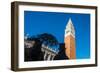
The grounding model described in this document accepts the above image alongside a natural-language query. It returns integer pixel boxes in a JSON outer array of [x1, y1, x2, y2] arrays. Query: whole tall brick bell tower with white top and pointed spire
[[64, 19, 76, 59]]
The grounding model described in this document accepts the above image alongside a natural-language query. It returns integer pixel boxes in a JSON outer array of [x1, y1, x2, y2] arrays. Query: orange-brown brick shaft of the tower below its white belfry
[[65, 35, 76, 59]]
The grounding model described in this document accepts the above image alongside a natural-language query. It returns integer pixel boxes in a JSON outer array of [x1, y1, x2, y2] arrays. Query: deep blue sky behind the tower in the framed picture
[[24, 11, 90, 59]]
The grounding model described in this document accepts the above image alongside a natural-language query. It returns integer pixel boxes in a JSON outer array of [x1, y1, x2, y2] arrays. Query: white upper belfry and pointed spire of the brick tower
[[65, 18, 75, 38]]
